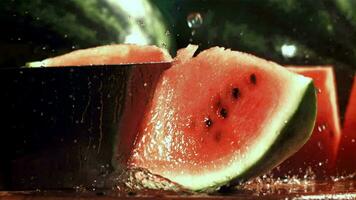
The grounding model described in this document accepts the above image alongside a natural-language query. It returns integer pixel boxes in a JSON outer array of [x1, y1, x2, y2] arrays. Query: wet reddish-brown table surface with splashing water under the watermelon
[[0, 178, 356, 200]]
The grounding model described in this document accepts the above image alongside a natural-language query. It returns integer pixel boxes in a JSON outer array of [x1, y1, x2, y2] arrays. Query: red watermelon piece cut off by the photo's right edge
[[337, 76, 356, 175]]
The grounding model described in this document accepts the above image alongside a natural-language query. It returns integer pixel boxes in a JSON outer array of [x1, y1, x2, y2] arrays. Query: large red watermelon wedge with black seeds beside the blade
[[129, 46, 316, 191]]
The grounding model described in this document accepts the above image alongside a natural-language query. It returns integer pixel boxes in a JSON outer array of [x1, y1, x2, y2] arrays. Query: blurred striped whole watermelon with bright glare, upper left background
[[0, 0, 174, 68]]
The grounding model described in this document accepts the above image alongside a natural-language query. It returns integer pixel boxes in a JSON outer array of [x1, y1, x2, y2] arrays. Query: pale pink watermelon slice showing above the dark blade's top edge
[[27, 44, 172, 67]]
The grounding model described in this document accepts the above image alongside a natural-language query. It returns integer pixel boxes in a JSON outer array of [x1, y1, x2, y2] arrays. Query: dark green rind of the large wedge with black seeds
[[228, 82, 317, 185]]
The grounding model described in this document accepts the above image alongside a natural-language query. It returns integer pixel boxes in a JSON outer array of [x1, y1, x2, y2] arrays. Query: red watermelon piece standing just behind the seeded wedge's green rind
[[273, 66, 341, 179]]
